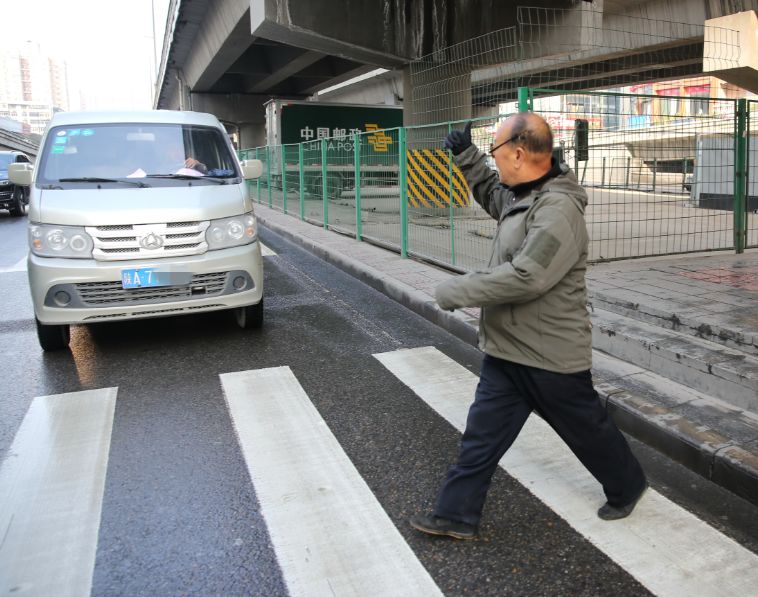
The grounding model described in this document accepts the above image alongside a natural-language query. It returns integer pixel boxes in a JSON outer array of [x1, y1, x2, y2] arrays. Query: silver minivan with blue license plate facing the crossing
[[9, 110, 263, 350]]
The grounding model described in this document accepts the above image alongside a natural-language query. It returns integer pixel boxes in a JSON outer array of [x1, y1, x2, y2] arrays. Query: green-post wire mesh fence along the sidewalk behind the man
[[240, 89, 758, 270]]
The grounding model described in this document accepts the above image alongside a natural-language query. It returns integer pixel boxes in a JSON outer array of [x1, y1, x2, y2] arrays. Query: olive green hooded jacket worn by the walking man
[[436, 146, 592, 373]]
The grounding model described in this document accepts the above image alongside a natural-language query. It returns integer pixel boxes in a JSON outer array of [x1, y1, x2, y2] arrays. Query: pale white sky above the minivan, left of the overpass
[[0, 0, 170, 109]]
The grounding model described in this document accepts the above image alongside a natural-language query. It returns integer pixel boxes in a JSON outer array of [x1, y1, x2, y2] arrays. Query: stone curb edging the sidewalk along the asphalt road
[[256, 212, 758, 505]]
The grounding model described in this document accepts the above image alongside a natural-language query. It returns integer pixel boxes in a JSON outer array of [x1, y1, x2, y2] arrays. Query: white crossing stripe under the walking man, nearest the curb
[[374, 347, 758, 596]]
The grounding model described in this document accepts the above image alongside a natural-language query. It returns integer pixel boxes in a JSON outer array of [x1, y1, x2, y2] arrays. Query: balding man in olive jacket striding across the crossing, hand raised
[[410, 112, 647, 539]]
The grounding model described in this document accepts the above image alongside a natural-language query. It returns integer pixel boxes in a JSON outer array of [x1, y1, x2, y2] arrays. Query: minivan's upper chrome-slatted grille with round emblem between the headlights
[[86, 221, 210, 261]]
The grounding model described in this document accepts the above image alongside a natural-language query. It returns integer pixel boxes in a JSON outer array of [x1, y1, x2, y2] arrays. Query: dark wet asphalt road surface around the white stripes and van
[[0, 207, 758, 596]]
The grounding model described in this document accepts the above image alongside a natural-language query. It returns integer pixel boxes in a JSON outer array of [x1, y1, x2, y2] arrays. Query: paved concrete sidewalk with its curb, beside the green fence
[[255, 205, 758, 504]]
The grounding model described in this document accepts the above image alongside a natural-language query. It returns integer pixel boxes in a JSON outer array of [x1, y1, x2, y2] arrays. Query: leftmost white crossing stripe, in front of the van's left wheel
[[0, 388, 117, 596]]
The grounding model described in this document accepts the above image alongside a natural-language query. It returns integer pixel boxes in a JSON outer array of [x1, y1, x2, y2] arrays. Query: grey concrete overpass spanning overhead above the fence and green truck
[[155, 0, 758, 147]]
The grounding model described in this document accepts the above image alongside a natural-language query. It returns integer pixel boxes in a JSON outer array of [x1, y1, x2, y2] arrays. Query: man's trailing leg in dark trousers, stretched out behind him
[[514, 365, 646, 512]]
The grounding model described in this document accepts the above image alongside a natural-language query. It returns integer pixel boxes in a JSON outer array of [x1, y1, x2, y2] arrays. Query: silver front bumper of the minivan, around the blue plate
[[28, 241, 263, 325]]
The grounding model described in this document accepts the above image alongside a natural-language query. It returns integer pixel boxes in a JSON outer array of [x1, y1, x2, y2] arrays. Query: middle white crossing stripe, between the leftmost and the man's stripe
[[220, 367, 441, 597]]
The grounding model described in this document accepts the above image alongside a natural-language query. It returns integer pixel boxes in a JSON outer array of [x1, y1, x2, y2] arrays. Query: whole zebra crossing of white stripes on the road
[[0, 347, 758, 596]]
